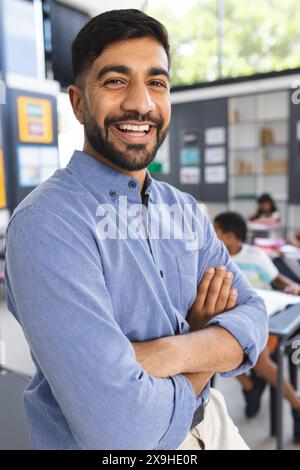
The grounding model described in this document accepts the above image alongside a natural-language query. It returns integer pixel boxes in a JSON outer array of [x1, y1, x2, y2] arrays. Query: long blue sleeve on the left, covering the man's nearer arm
[[6, 206, 197, 449]]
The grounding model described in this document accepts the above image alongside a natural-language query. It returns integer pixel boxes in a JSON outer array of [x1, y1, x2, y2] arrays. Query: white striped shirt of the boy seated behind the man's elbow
[[232, 243, 279, 289]]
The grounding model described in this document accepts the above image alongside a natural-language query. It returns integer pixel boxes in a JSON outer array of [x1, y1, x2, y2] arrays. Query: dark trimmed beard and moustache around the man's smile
[[84, 107, 169, 171]]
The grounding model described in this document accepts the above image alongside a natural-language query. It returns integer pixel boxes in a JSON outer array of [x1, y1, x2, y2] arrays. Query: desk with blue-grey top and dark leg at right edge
[[269, 304, 300, 450]]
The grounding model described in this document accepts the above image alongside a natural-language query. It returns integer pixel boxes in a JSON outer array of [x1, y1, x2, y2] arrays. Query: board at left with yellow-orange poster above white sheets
[[4, 88, 59, 210]]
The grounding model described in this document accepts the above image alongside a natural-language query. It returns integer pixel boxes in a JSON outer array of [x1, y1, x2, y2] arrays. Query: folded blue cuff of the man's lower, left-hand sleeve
[[156, 375, 197, 450]]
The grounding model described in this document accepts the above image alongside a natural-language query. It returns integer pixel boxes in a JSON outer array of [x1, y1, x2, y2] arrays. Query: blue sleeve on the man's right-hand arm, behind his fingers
[[199, 212, 268, 377]]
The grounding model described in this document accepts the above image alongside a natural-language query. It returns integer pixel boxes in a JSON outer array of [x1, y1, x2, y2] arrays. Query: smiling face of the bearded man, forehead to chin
[[79, 37, 170, 171]]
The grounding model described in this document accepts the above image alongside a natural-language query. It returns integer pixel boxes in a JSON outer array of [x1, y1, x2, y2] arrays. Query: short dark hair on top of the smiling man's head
[[72, 9, 170, 81]]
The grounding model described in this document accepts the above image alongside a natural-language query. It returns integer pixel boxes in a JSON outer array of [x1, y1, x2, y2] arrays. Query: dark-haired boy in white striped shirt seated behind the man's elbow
[[214, 212, 300, 443]]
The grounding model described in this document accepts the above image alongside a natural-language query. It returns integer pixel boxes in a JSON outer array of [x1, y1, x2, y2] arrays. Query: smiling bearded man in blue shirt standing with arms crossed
[[6, 10, 267, 449]]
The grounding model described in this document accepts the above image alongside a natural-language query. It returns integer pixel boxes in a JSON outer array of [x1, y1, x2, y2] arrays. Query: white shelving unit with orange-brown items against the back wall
[[228, 90, 289, 228]]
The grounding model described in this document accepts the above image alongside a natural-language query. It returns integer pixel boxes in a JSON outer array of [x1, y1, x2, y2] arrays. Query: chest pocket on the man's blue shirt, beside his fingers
[[176, 251, 198, 317]]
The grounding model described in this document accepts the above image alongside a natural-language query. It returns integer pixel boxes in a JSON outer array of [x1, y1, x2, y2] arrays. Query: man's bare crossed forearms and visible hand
[[132, 266, 244, 396]]
